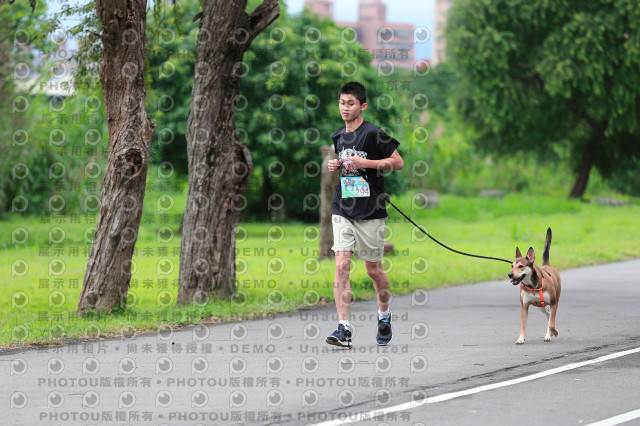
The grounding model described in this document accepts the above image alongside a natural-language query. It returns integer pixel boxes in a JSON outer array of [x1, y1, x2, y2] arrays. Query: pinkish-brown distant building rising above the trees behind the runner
[[305, 0, 416, 68]]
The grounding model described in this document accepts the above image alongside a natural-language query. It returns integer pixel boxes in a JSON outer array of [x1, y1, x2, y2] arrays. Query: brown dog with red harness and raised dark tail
[[509, 228, 560, 344]]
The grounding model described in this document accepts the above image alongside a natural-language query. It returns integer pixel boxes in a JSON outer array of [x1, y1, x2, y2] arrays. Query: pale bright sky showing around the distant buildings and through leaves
[[47, 0, 435, 59]]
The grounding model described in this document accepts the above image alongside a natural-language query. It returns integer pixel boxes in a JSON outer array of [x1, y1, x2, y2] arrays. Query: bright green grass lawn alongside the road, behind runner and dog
[[0, 188, 640, 347]]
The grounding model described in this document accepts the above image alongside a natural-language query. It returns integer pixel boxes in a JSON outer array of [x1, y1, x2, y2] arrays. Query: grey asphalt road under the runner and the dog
[[0, 260, 640, 425]]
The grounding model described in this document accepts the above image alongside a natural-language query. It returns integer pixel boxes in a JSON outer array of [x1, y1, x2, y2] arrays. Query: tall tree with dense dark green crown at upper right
[[447, 0, 640, 198]]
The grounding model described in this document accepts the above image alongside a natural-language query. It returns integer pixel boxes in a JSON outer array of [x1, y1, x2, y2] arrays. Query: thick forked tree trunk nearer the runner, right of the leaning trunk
[[178, 0, 280, 305]]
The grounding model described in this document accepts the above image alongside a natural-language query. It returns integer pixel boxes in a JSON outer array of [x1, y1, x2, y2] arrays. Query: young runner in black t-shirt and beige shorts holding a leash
[[327, 82, 404, 347]]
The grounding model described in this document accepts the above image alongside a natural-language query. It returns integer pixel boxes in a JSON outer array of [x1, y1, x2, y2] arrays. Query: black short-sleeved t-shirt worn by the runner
[[331, 121, 400, 220]]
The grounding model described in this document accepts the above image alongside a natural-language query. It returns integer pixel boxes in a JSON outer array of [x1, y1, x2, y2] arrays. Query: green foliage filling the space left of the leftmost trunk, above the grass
[[0, 1, 106, 214]]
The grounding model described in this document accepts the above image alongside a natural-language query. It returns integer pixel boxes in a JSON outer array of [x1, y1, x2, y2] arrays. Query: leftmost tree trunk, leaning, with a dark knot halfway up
[[78, 0, 155, 315]]
